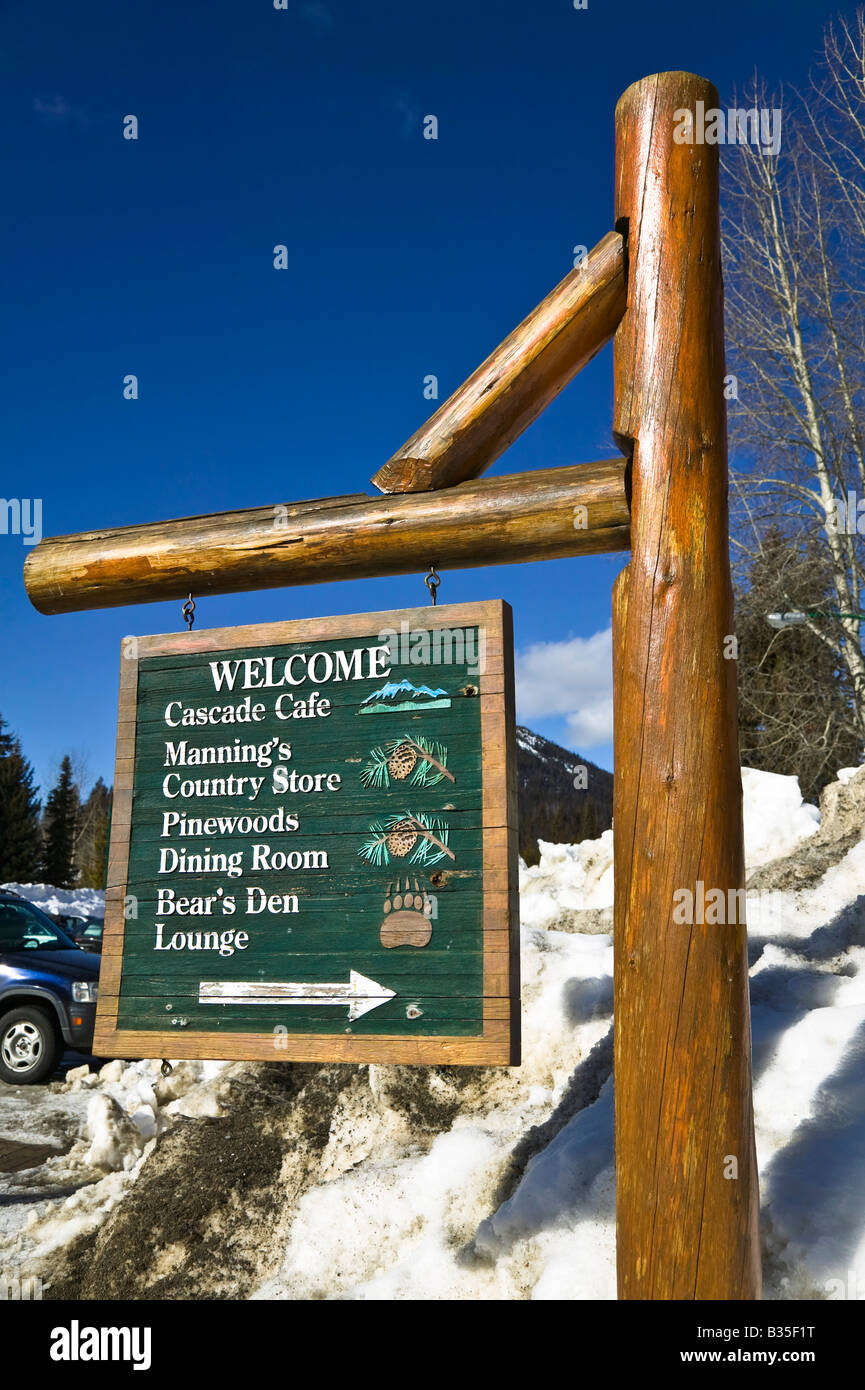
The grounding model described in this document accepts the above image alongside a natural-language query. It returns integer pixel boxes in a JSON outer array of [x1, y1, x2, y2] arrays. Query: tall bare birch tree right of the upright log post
[[722, 10, 865, 745]]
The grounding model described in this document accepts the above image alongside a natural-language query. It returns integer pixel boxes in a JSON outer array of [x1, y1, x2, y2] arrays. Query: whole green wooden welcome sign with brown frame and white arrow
[[93, 600, 519, 1065]]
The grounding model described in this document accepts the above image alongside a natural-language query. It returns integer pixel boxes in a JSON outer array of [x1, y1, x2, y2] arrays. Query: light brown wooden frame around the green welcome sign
[[93, 600, 520, 1066]]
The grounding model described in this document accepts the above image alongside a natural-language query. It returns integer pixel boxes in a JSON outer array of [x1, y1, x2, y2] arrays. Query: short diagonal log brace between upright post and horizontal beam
[[371, 232, 624, 492]]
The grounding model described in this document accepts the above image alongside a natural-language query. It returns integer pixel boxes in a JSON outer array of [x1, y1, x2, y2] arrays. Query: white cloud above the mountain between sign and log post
[[515, 627, 613, 748]]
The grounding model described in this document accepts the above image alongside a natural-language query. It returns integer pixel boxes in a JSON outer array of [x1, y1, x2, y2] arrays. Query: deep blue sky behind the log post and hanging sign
[[0, 0, 856, 791]]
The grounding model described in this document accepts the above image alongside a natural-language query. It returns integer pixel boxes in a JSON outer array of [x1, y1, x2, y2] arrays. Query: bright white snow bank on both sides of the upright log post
[[250, 769, 865, 1300]]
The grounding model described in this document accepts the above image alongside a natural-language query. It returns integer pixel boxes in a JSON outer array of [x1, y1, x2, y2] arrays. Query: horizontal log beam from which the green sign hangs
[[24, 459, 629, 613]]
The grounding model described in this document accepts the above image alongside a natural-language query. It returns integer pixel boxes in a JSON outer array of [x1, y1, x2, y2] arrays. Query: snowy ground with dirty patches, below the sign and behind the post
[[0, 769, 865, 1300]]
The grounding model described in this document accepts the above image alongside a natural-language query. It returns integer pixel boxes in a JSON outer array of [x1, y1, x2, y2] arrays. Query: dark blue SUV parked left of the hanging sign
[[0, 891, 99, 1086]]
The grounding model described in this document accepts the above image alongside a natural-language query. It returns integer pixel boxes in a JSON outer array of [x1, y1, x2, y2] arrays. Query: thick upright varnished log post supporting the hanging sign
[[613, 72, 761, 1300]]
